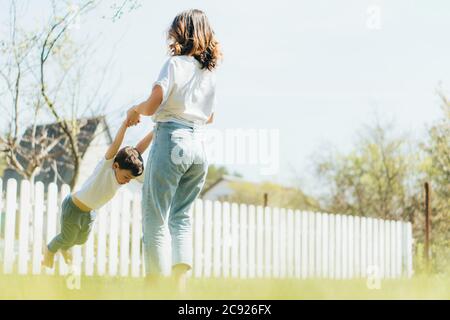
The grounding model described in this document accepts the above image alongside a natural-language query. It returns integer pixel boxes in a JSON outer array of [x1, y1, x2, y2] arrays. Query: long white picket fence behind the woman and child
[[0, 179, 413, 279]]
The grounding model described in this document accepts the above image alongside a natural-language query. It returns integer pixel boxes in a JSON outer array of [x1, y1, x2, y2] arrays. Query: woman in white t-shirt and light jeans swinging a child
[[127, 10, 221, 290]]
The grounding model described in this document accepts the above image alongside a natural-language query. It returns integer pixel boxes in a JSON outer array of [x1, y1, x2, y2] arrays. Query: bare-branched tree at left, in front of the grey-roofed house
[[0, 0, 112, 188]]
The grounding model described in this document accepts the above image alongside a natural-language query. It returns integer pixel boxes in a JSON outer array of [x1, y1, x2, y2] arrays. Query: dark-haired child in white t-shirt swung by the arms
[[42, 121, 153, 268]]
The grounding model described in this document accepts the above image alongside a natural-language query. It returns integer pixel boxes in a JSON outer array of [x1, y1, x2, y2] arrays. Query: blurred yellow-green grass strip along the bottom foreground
[[0, 274, 450, 300]]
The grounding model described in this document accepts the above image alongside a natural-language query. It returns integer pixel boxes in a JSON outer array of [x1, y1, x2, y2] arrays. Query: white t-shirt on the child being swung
[[74, 157, 122, 210]]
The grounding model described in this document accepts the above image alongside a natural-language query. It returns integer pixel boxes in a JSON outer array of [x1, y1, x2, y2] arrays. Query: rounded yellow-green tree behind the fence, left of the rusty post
[[315, 121, 418, 220]]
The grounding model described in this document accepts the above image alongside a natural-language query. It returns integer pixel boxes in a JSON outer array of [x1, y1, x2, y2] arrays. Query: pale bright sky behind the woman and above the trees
[[0, 0, 450, 192]]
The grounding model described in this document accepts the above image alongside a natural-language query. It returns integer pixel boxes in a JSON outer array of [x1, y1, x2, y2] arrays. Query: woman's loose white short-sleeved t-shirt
[[153, 56, 216, 125]]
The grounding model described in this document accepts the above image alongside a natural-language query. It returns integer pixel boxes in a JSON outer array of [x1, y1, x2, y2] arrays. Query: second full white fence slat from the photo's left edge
[[18, 180, 32, 274]]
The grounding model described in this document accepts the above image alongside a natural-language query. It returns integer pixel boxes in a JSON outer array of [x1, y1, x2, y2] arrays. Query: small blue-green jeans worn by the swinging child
[[47, 195, 95, 253]]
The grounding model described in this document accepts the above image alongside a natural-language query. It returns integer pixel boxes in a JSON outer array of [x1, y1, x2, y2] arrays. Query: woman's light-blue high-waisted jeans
[[142, 122, 208, 275]]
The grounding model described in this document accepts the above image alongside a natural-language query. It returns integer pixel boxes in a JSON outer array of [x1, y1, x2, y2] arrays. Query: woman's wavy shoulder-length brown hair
[[167, 9, 222, 71]]
